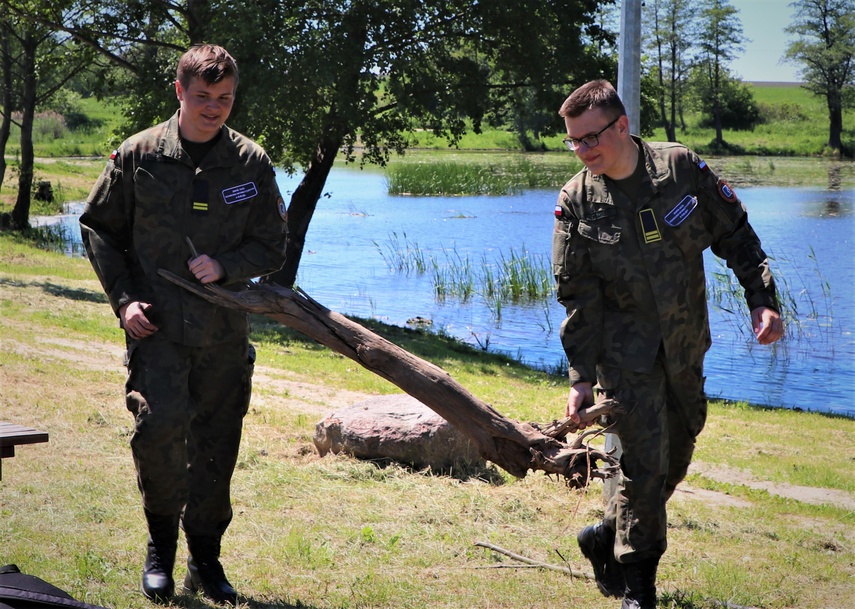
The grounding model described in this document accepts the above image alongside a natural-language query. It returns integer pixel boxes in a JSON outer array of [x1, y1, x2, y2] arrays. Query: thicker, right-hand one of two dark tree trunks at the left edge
[[12, 32, 38, 230]]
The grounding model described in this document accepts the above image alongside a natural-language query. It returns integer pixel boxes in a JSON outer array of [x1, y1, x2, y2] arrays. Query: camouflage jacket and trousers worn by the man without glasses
[[80, 113, 286, 536]]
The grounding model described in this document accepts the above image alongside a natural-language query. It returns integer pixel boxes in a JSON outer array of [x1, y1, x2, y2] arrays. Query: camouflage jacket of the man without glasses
[[80, 112, 286, 346]]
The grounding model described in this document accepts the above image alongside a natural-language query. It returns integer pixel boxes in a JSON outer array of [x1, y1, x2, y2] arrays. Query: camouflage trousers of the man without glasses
[[125, 333, 255, 536]]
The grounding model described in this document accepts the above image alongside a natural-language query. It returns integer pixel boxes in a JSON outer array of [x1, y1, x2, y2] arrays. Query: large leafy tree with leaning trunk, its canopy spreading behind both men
[[11, 0, 615, 276]]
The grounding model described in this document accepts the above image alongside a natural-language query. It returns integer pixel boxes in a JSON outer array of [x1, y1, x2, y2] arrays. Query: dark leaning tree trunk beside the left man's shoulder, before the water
[[264, 135, 343, 287]]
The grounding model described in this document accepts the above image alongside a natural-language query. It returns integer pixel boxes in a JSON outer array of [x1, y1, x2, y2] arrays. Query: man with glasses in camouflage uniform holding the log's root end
[[553, 80, 783, 609]]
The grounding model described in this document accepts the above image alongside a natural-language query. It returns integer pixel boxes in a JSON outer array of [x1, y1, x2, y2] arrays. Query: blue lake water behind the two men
[[41, 162, 855, 416]]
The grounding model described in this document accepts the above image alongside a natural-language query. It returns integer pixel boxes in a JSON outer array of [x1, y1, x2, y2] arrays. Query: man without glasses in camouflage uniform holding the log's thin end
[[80, 45, 286, 605]]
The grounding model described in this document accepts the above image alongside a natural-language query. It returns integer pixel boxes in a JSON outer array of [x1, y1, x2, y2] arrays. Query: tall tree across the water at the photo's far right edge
[[785, 0, 855, 152]]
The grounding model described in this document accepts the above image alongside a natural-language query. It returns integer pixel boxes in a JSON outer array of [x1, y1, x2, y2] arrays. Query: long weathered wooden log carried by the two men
[[159, 269, 618, 487]]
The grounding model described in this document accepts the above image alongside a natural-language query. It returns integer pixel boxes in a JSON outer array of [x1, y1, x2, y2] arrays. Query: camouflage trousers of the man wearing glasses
[[598, 349, 707, 563]]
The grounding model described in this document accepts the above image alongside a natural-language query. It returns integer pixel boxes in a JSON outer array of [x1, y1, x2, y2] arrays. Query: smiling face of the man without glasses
[[175, 77, 236, 143]]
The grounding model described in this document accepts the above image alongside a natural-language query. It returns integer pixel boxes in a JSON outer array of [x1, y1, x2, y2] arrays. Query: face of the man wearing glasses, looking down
[[564, 108, 632, 179]]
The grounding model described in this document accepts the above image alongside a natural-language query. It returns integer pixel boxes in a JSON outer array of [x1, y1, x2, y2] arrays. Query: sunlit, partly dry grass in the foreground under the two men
[[0, 233, 855, 609]]
